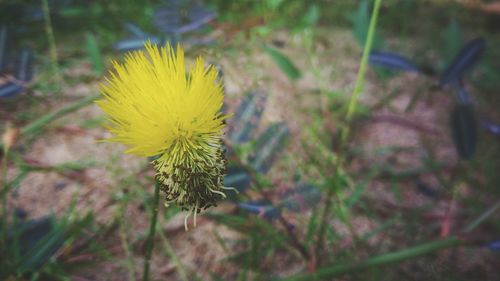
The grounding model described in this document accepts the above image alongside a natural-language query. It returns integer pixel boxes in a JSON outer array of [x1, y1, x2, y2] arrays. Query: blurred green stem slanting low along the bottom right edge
[[275, 236, 458, 281]]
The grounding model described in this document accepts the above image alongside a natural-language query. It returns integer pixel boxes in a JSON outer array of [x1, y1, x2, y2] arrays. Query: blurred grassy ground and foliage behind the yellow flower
[[0, 0, 500, 281]]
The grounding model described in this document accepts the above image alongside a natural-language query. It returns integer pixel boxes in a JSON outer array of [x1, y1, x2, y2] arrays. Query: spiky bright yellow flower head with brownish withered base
[[97, 44, 227, 224]]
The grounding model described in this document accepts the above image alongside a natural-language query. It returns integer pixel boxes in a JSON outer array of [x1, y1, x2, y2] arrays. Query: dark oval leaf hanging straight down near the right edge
[[450, 105, 477, 160]]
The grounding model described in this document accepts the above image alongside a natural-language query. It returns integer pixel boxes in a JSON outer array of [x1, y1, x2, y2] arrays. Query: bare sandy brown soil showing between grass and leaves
[[1, 26, 498, 280]]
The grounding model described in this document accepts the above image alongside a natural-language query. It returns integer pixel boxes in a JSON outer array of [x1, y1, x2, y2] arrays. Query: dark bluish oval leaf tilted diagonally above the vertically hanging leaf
[[439, 38, 486, 86]]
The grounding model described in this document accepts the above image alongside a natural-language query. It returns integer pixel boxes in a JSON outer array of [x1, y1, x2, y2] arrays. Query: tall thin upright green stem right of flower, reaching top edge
[[315, 0, 382, 255]]
